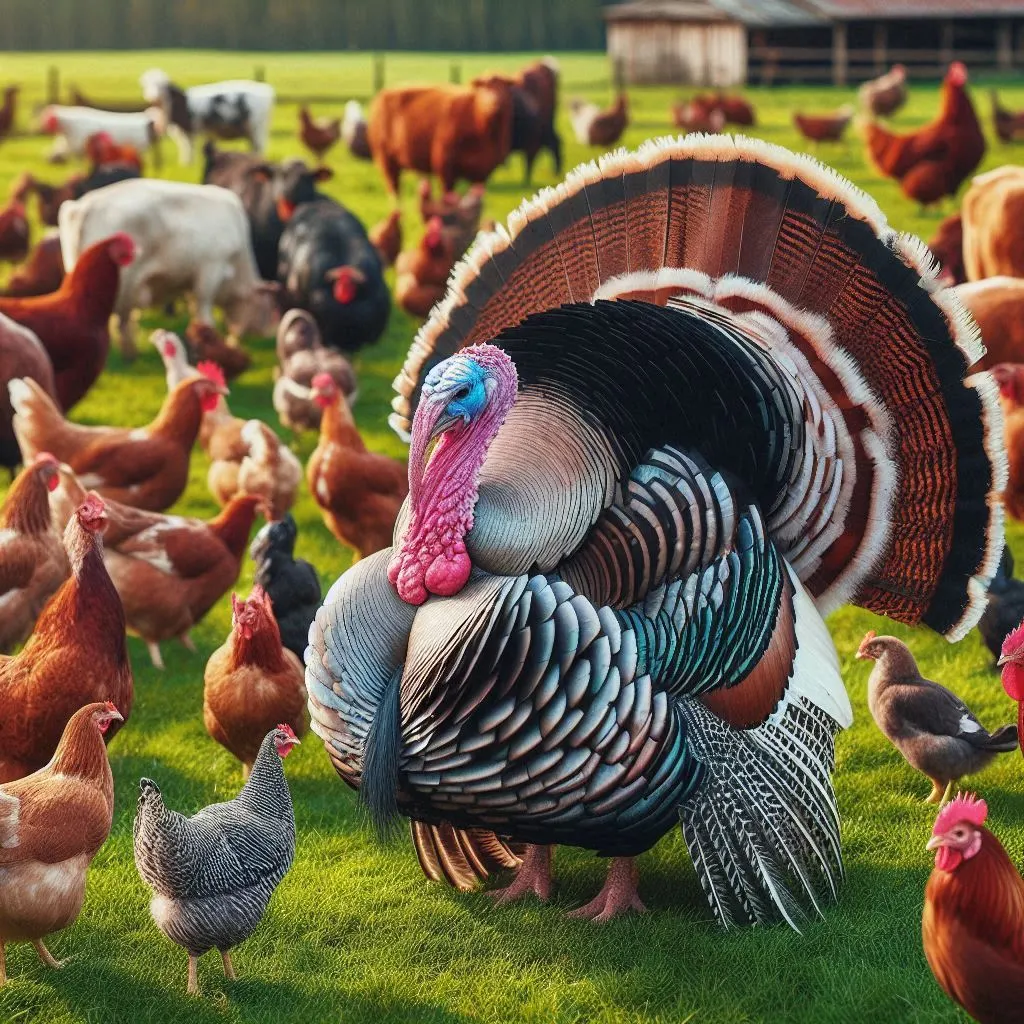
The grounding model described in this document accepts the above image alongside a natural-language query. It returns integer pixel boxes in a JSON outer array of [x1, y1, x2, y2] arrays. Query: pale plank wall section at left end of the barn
[[608, 22, 746, 86]]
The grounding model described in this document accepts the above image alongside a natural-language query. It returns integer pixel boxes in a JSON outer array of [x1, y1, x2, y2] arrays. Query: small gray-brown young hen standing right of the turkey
[[857, 632, 1017, 803]]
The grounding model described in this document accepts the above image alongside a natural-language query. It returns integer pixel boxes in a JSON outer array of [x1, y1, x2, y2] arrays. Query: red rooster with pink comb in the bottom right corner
[[922, 795, 1024, 1024]]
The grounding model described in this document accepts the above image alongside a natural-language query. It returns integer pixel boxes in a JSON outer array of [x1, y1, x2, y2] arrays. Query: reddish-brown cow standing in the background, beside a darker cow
[[368, 85, 512, 200]]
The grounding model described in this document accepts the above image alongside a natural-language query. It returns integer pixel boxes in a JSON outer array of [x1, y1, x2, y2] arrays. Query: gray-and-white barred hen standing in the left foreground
[[133, 725, 299, 993]]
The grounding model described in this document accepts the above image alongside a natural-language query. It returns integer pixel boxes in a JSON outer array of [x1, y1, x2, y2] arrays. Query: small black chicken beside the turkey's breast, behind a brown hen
[[249, 512, 321, 658]]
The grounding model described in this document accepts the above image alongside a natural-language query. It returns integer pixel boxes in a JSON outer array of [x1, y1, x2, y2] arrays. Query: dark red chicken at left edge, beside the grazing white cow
[[0, 233, 135, 413]]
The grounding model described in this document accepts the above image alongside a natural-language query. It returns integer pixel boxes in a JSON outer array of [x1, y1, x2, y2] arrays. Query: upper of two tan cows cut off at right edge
[[961, 166, 1024, 281]]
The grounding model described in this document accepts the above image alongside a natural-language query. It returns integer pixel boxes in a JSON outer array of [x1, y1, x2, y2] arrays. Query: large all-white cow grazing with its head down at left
[[57, 178, 276, 357]]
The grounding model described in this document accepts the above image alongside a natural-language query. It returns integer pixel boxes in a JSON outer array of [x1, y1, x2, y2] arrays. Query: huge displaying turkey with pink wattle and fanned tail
[[306, 136, 1006, 928]]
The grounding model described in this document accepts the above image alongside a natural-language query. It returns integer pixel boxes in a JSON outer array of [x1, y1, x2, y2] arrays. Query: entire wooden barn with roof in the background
[[604, 0, 1024, 86]]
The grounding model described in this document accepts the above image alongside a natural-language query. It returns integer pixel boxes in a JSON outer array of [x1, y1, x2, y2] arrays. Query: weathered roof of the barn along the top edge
[[604, 0, 1024, 27]]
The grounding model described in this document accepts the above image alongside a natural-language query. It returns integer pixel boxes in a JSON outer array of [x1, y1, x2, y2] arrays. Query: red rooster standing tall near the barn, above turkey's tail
[[864, 60, 985, 206]]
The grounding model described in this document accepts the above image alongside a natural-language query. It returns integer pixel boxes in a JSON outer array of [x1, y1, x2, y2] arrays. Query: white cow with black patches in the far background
[[139, 68, 274, 164]]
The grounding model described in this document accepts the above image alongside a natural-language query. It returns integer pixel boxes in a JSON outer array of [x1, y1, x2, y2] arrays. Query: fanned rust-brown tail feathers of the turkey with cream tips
[[391, 135, 1006, 640]]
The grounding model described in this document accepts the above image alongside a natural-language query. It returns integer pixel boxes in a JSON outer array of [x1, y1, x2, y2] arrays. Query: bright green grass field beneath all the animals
[[0, 52, 1024, 1024]]
